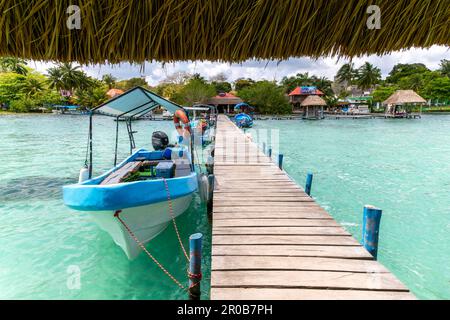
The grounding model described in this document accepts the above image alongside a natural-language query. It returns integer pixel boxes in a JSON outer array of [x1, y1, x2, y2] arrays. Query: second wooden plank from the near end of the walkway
[[211, 270, 408, 291]]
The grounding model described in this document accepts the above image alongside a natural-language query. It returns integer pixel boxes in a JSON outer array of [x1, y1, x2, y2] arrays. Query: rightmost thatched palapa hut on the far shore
[[383, 90, 427, 118]]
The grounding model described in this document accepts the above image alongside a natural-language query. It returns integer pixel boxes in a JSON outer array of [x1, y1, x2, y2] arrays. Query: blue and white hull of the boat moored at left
[[63, 149, 198, 259]]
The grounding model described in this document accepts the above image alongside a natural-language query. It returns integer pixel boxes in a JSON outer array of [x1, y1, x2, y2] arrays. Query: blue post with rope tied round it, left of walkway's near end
[[188, 233, 203, 300]]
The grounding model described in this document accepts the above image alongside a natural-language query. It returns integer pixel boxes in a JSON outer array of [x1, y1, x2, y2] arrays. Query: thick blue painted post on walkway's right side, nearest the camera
[[362, 205, 383, 260]]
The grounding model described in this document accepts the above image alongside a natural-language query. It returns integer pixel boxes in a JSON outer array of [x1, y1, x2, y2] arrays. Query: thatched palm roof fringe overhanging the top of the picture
[[0, 0, 450, 63]]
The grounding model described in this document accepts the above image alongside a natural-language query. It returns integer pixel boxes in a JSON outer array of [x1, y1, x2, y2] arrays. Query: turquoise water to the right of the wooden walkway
[[255, 115, 450, 299]]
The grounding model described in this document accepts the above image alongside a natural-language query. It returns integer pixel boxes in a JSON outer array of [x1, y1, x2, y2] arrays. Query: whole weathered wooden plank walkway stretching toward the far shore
[[211, 115, 414, 300]]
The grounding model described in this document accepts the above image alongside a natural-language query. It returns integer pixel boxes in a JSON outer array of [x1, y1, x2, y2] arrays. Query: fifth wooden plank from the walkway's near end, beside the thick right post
[[212, 233, 360, 246]]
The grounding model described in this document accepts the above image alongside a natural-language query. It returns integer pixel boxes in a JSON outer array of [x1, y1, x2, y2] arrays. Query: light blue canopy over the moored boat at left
[[93, 87, 183, 118]]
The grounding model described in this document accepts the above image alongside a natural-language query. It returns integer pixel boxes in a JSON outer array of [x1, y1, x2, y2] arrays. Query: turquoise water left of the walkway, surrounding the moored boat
[[0, 115, 211, 299]]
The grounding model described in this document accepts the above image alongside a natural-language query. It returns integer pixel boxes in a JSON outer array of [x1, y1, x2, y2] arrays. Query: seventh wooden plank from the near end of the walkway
[[213, 219, 340, 227]]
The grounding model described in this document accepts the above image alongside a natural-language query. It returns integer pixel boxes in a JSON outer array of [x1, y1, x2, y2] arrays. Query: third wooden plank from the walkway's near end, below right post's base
[[211, 255, 389, 273]]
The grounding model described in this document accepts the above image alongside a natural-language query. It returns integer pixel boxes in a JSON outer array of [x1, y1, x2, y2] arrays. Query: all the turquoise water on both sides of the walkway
[[0, 115, 450, 299]]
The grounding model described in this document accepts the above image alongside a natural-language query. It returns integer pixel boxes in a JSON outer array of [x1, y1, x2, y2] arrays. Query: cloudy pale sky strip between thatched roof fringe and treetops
[[30, 46, 450, 86]]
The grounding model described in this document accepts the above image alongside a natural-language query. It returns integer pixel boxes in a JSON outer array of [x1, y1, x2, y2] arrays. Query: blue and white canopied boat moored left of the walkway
[[63, 87, 198, 259]]
